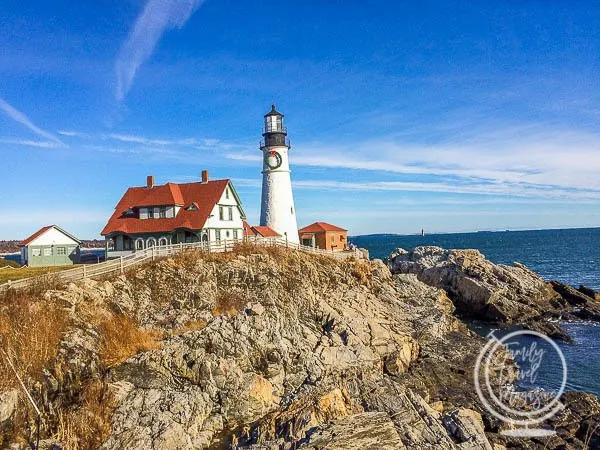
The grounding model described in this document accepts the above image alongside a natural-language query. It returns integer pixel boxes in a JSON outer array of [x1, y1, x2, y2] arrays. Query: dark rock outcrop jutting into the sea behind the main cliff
[[387, 247, 600, 340]]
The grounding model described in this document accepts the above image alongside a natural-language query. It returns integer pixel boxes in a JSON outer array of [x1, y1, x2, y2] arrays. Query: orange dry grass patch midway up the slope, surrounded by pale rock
[[98, 315, 163, 367]]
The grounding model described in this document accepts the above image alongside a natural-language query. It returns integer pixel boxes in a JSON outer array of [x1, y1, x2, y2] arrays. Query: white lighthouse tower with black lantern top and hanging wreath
[[260, 105, 299, 243]]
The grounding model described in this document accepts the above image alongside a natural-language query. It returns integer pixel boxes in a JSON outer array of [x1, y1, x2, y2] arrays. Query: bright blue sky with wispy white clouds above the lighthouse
[[0, 0, 600, 239]]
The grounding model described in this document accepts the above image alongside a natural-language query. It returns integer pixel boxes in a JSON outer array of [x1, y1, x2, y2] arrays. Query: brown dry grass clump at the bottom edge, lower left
[[56, 381, 115, 450]]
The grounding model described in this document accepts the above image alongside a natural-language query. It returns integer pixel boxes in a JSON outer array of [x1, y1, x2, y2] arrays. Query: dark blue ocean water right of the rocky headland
[[349, 228, 600, 396]]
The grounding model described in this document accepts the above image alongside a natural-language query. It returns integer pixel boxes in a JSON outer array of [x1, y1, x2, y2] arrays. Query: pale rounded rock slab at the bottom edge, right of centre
[[299, 412, 406, 450]]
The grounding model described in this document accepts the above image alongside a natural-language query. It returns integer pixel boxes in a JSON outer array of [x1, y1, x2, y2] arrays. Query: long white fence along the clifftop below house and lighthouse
[[0, 238, 361, 290]]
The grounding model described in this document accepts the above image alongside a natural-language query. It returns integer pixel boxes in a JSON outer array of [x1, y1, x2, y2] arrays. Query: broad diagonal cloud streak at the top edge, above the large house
[[115, 0, 203, 102]]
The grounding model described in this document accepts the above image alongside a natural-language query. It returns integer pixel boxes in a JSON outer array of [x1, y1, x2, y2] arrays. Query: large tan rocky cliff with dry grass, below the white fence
[[0, 246, 600, 450]]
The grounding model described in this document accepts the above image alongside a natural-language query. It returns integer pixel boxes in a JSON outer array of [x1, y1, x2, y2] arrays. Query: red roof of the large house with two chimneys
[[101, 180, 229, 236]]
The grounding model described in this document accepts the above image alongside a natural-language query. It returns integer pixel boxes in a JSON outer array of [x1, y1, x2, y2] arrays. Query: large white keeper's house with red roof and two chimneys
[[102, 170, 246, 256]]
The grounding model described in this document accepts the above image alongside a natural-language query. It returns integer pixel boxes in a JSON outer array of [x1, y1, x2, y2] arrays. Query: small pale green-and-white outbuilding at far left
[[19, 225, 81, 267]]
